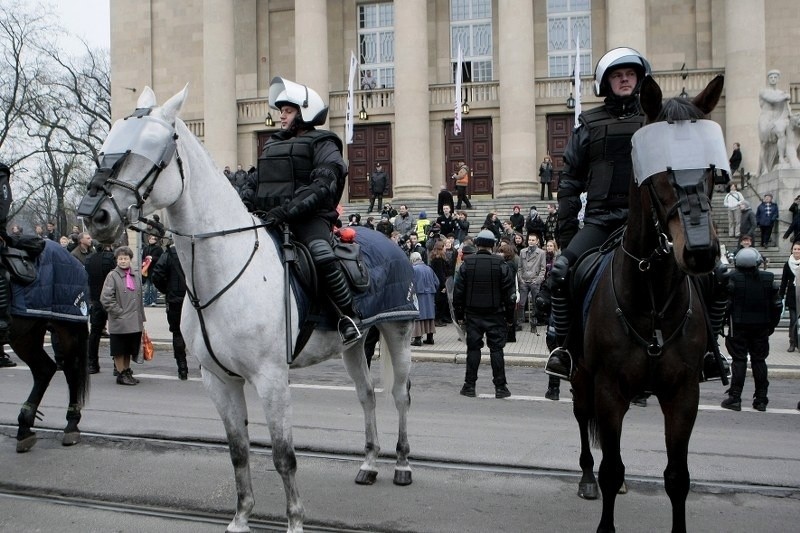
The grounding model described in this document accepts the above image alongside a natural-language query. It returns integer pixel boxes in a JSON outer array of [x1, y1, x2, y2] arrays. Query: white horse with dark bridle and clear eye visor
[[79, 87, 413, 533]]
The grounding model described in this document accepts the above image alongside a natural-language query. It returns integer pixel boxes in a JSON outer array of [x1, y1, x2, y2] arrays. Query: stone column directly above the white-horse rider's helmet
[[292, 0, 330, 113]]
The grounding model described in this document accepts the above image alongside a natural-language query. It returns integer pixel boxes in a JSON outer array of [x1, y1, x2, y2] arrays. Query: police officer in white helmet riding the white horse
[[242, 77, 361, 344]]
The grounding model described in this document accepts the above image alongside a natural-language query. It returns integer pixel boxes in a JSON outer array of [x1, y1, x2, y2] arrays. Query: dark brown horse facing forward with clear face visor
[[570, 76, 727, 532]]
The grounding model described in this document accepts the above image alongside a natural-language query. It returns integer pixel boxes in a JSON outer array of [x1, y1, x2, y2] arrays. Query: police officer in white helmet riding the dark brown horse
[[536, 47, 650, 379]]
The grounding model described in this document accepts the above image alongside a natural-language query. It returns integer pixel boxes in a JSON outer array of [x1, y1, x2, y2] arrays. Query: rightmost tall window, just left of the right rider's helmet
[[547, 0, 593, 77]]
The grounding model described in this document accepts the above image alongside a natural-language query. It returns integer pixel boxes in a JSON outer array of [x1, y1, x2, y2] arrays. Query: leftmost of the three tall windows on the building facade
[[358, 2, 394, 88]]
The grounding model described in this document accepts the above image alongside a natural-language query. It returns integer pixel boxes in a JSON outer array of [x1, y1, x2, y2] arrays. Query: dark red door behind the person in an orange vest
[[444, 117, 494, 194]]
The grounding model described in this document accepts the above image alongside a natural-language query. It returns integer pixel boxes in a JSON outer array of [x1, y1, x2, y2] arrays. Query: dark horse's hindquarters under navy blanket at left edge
[[9, 241, 89, 453]]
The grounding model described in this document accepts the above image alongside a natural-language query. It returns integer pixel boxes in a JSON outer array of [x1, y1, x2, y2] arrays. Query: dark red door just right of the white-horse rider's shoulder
[[347, 124, 392, 200]]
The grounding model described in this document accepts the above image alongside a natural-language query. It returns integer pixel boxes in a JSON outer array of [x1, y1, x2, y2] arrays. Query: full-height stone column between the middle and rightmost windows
[[496, 0, 539, 197]]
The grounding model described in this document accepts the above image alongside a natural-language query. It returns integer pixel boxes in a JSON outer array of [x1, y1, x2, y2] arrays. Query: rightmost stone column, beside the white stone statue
[[725, 0, 764, 180]]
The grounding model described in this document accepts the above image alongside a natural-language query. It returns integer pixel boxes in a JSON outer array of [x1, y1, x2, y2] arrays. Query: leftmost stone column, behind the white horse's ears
[[203, 0, 239, 168]]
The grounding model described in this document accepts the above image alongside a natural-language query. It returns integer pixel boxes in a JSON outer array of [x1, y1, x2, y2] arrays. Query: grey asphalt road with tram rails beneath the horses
[[0, 352, 800, 532]]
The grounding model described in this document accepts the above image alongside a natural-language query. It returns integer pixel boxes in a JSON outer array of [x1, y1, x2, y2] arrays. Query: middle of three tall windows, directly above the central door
[[450, 0, 494, 83]]
